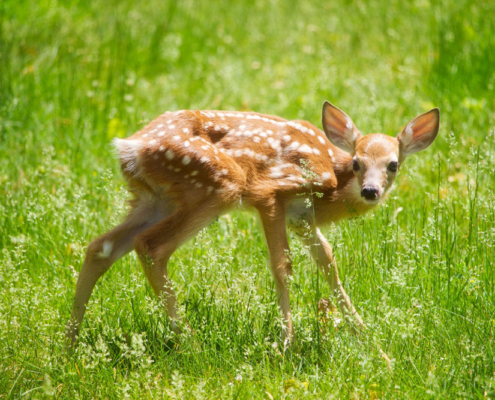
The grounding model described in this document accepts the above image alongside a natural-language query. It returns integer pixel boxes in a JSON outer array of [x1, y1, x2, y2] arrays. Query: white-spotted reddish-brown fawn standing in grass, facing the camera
[[66, 102, 440, 347]]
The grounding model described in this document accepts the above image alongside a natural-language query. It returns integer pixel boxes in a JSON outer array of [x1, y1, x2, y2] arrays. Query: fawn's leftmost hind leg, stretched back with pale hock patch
[[66, 201, 169, 348]]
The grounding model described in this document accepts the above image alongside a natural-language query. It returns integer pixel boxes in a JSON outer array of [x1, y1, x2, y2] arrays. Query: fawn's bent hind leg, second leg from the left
[[134, 192, 223, 333]]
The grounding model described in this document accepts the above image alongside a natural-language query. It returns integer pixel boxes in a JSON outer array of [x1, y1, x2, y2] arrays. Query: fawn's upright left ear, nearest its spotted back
[[322, 101, 361, 154]]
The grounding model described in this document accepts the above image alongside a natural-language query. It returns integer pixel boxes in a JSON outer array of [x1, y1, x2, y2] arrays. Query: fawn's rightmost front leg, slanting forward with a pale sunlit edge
[[301, 228, 366, 329]]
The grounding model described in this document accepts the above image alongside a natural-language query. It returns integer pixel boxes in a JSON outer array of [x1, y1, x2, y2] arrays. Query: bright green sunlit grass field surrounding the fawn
[[0, 0, 495, 399]]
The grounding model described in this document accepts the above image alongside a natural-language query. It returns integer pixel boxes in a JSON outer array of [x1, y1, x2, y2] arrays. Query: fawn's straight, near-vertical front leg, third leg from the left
[[258, 204, 294, 344]]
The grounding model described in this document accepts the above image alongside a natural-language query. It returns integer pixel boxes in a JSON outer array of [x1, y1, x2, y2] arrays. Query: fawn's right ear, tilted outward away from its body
[[397, 108, 440, 157]]
